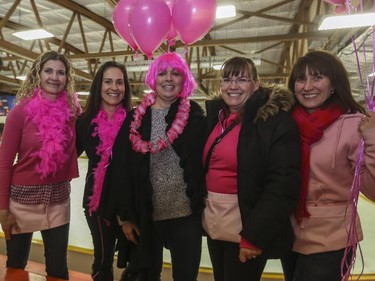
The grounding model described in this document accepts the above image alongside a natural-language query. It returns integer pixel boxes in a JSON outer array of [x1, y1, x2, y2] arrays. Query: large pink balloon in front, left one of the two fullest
[[129, 0, 172, 59]]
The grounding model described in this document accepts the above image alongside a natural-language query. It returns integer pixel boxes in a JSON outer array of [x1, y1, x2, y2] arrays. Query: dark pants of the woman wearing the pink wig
[[150, 212, 202, 281]]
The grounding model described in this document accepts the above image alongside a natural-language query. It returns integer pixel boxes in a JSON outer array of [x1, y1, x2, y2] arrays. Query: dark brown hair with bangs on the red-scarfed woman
[[288, 51, 365, 113]]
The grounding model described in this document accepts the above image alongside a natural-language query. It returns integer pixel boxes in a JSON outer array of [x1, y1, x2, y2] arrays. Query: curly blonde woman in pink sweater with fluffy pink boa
[[0, 51, 81, 279]]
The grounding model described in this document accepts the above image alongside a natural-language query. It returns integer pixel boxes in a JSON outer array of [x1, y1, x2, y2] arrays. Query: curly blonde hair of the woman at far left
[[16, 51, 77, 114]]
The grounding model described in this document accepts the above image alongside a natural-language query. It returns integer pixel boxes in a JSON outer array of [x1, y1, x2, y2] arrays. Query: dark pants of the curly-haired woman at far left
[[6, 223, 69, 280]]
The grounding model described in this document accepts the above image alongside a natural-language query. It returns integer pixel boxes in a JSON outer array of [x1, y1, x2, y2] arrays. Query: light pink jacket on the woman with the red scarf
[[292, 114, 375, 254]]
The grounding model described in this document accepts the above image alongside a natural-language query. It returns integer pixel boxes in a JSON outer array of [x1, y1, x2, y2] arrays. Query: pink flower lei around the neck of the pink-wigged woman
[[129, 92, 190, 154]]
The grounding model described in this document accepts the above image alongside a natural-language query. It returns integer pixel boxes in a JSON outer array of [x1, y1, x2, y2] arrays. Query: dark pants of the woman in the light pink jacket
[[281, 249, 352, 281]]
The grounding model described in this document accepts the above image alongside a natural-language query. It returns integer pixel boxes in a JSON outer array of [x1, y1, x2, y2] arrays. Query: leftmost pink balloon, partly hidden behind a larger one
[[112, 0, 138, 51]]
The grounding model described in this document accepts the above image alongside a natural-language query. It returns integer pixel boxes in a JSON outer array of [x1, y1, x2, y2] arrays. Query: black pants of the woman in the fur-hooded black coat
[[207, 237, 267, 281]]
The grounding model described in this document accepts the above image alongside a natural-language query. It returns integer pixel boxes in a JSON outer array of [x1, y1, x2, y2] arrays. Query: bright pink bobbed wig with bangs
[[145, 52, 197, 97]]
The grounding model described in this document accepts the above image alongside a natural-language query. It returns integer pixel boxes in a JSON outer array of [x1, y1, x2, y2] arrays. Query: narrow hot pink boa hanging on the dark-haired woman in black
[[88, 106, 126, 215]]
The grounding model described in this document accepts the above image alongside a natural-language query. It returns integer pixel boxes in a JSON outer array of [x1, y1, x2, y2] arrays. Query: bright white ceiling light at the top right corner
[[319, 13, 375, 30]]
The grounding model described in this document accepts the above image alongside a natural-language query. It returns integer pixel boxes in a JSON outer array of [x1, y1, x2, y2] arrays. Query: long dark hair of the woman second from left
[[82, 61, 131, 119]]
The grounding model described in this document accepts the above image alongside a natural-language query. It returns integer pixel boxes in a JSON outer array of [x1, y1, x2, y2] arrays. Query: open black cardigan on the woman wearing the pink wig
[[102, 97, 205, 280]]
